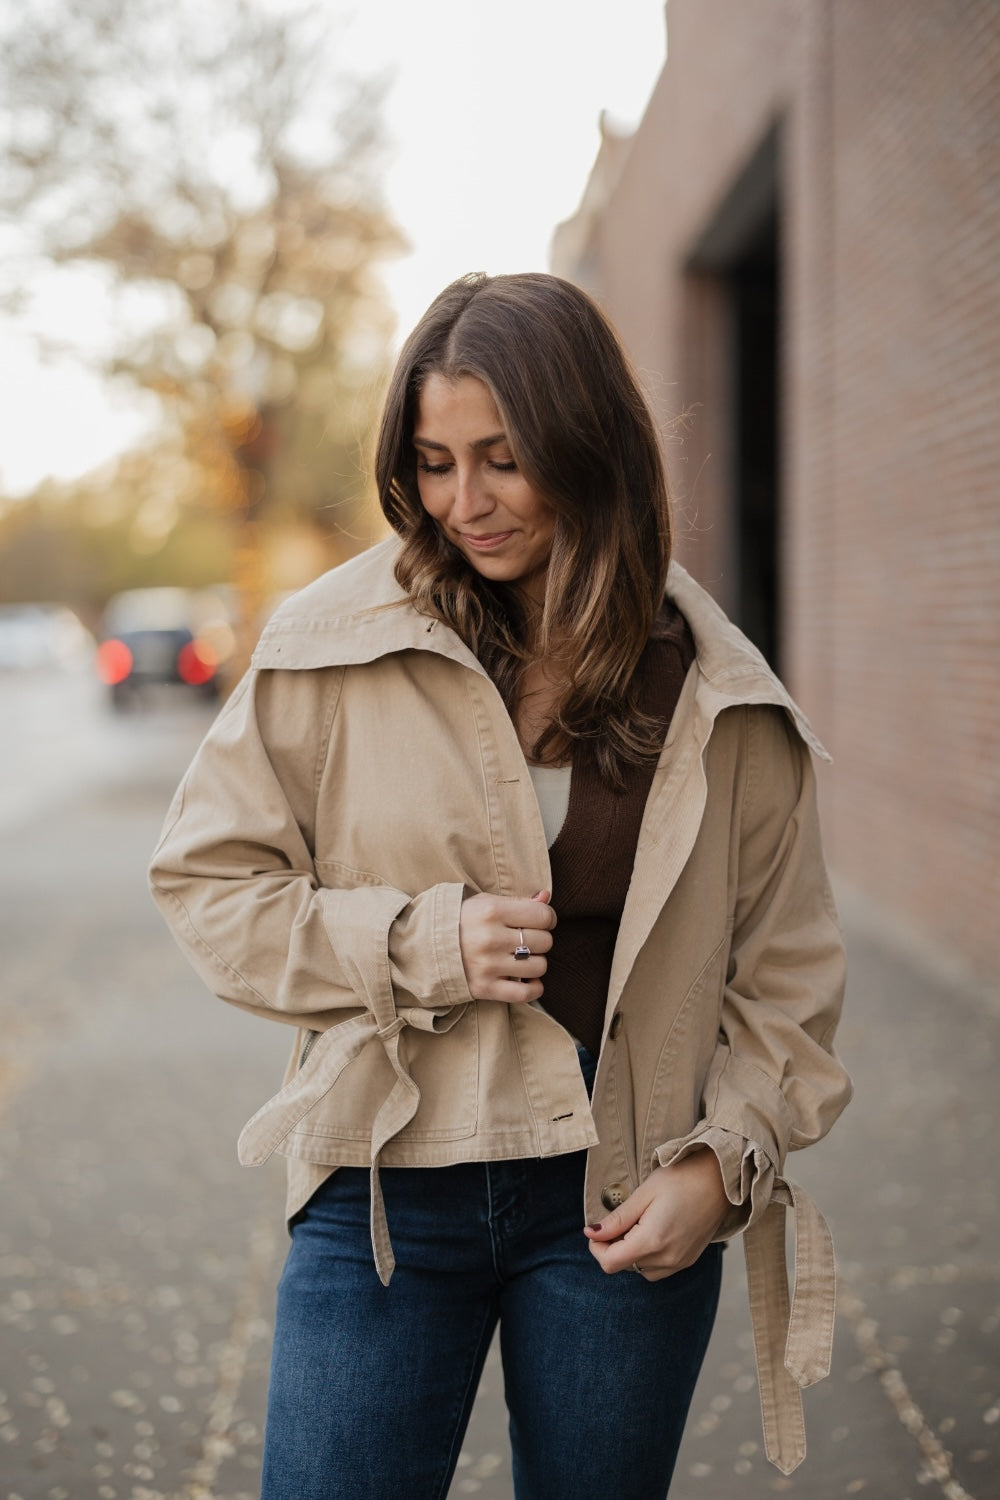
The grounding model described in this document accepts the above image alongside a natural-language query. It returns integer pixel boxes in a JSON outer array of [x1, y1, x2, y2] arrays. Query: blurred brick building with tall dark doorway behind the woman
[[553, 0, 1000, 986]]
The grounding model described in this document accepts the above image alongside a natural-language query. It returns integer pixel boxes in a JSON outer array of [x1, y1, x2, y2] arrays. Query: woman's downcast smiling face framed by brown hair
[[414, 375, 556, 603]]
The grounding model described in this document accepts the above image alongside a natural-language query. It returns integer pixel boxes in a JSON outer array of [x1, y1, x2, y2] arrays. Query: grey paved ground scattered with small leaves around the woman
[[0, 681, 1000, 1500]]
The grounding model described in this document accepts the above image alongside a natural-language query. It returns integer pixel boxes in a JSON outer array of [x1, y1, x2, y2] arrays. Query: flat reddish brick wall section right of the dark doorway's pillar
[[821, 0, 1000, 974]]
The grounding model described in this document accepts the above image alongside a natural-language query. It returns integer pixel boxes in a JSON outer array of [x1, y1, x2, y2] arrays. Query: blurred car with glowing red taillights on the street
[[96, 588, 234, 708]]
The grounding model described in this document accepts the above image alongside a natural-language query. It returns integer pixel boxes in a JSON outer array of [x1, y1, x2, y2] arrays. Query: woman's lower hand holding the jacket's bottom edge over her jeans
[[583, 1146, 729, 1281]]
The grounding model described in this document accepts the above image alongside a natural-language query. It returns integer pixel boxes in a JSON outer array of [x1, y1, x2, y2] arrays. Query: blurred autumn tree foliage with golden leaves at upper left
[[0, 0, 402, 597]]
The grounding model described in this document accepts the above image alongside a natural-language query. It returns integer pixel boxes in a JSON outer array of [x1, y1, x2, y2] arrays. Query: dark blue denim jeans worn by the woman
[[261, 1059, 721, 1500]]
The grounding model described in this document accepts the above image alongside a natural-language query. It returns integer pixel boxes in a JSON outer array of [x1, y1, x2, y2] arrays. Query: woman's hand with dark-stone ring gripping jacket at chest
[[459, 891, 556, 1005]]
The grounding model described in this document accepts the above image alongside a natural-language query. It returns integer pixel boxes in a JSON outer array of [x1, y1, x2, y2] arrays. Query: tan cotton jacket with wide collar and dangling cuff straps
[[151, 540, 850, 1472]]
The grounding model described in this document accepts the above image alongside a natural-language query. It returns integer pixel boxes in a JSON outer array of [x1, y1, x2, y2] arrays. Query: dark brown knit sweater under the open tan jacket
[[541, 600, 694, 1056]]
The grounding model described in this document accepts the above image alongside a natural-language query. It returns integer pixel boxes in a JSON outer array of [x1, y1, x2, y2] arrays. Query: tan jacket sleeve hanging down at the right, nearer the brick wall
[[657, 708, 852, 1238]]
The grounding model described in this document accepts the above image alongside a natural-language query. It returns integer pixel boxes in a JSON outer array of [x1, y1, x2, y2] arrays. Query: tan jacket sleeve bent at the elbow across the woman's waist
[[150, 668, 471, 1031]]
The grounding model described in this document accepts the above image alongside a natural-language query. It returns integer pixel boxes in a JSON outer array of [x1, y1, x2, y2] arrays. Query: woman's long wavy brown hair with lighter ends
[[375, 273, 672, 785]]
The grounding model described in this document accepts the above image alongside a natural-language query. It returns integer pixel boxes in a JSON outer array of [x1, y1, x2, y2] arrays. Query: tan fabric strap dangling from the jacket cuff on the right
[[744, 1178, 837, 1475]]
